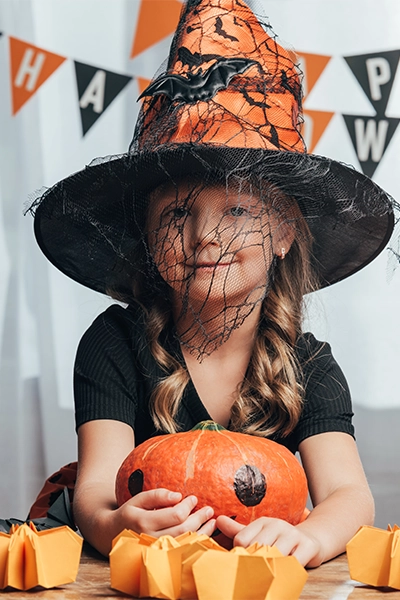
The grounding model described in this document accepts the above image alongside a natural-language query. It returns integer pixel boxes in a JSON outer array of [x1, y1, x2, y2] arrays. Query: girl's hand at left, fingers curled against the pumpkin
[[113, 488, 215, 537]]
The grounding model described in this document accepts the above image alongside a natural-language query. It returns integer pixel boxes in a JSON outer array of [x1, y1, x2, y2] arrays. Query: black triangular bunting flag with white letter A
[[74, 61, 132, 135]]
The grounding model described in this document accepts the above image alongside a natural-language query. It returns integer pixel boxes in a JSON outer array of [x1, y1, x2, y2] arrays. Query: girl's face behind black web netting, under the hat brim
[[147, 182, 287, 306]]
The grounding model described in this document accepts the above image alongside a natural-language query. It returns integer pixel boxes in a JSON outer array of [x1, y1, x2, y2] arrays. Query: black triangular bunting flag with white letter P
[[344, 50, 400, 117]]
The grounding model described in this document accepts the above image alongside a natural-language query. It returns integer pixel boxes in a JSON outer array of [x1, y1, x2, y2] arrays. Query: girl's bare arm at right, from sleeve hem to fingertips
[[216, 432, 374, 567]]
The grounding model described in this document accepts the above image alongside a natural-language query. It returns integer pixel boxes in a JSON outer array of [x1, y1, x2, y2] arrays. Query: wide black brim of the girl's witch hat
[[33, 144, 394, 294]]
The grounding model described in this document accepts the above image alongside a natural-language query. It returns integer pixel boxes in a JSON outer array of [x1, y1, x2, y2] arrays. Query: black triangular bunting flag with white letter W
[[343, 115, 400, 177]]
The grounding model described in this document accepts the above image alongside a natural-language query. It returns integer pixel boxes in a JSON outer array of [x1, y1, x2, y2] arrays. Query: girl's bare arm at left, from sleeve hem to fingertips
[[73, 420, 215, 555]]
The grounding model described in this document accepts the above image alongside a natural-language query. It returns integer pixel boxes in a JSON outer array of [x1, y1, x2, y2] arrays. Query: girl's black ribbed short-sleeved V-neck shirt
[[74, 305, 354, 452]]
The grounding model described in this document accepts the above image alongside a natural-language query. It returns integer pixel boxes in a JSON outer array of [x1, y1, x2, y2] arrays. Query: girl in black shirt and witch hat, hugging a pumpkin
[[29, 0, 393, 566]]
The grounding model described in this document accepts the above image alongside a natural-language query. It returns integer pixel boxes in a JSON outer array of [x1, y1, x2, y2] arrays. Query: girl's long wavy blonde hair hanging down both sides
[[114, 176, 317, 437]]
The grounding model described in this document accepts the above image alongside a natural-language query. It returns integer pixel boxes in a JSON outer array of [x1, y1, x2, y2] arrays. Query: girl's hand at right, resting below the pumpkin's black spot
[[216, 516, 321, 566]]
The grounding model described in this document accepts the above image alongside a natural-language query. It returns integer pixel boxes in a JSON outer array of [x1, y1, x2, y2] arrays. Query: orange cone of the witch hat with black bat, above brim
[[138, 0, 305, 152]]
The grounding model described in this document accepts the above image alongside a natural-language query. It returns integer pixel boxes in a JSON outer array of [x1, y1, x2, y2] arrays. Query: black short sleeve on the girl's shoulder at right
[[293, 333, 354, 447]]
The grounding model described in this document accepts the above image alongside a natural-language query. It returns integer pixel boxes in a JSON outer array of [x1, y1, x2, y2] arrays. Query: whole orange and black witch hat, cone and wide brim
[[32, 0, 394, 308]]
